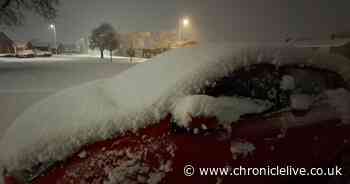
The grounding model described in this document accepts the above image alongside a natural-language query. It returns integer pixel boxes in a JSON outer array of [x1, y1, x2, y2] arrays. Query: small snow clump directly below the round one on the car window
[[290, 94, 314, 110]]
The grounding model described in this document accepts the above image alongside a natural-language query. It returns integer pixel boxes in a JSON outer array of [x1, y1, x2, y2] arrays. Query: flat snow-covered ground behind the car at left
[[0, 55, 144, 138]]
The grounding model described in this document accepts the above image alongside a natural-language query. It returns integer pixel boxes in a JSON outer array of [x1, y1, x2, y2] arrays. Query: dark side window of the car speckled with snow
[[204, 64, 345, 111]]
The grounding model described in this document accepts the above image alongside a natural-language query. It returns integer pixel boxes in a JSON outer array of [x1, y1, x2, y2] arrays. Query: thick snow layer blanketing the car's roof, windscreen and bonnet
[[0, 44, 350, 171]]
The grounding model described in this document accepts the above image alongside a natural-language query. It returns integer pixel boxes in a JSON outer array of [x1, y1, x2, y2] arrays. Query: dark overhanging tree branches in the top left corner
[[0, 0, 60, 26]]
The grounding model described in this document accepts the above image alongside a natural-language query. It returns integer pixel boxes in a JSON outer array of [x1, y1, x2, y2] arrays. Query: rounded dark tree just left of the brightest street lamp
[[90, 23, 119, 59]]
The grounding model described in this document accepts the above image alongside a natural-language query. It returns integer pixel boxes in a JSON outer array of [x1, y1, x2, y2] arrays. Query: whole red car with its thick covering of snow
[[0, 44, 350, 184]]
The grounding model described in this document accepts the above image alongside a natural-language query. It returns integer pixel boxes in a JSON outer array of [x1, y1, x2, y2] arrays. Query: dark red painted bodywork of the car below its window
[[10, 113, 344, 184]]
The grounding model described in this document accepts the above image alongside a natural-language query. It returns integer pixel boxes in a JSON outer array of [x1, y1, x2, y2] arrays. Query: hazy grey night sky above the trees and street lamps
[[5, 0, 350, 42]]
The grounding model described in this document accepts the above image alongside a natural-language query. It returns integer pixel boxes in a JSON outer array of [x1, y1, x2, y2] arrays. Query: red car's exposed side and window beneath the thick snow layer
[[0, 45, 350, 184]]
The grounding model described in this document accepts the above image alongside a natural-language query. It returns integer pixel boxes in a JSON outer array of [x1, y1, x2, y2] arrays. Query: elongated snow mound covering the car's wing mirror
[[172, 95, 272, 127]]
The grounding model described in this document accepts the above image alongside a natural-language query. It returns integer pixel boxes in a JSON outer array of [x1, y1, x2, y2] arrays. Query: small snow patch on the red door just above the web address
[[230, 141, 256, 159]]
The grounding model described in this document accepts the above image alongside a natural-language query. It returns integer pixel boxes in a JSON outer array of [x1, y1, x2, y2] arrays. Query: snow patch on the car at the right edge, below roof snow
[[325, 88, 350, 123]]
